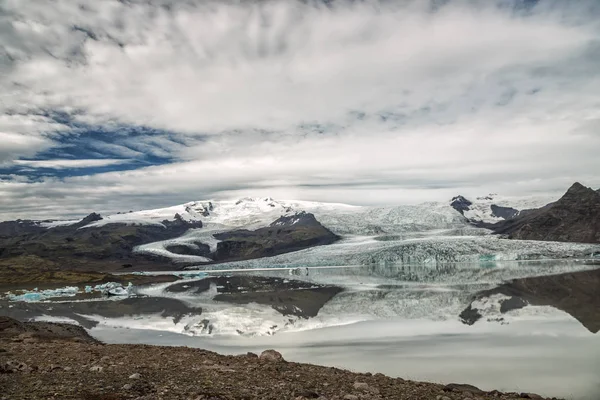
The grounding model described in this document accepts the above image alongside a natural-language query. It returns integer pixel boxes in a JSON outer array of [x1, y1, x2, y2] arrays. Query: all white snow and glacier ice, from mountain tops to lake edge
[[34, 194, 598, 268]]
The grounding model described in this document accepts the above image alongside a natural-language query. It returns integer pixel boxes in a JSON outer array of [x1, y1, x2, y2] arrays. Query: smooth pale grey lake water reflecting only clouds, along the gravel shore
[[92, 319, 600, 400]]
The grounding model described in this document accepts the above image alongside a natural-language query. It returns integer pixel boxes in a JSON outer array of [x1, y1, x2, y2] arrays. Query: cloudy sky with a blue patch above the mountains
[[0, 0, 600, 220]]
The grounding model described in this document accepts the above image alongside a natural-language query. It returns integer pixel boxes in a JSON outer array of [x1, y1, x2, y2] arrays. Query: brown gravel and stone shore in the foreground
[[0, 317, 556, 400]]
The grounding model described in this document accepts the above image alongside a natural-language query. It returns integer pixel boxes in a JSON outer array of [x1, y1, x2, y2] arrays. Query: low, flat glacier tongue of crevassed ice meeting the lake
[[194, 235, 600, 270]]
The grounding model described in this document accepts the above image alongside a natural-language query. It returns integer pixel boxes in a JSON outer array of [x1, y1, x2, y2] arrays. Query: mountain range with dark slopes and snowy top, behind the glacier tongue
[[0, 183, 600, 282]]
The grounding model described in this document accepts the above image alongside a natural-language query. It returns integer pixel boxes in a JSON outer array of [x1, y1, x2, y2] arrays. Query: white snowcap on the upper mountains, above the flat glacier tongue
[[43, 197, 465, 234]]
